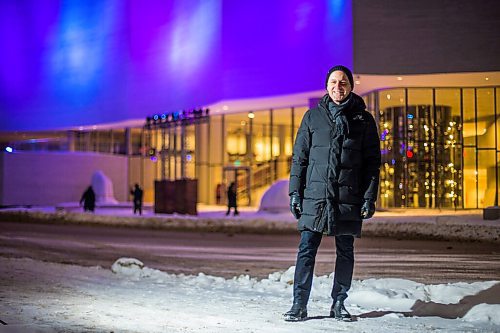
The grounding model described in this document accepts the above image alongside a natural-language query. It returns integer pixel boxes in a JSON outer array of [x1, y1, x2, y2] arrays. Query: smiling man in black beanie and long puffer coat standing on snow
[[284, 65, 381, 321]]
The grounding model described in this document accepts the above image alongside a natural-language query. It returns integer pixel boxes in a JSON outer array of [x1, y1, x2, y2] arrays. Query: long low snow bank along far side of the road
[[0, 209, 500, 243]]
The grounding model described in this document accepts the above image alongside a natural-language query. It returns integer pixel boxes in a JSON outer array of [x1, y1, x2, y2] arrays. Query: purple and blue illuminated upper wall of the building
[[0, 0, 353, 131]]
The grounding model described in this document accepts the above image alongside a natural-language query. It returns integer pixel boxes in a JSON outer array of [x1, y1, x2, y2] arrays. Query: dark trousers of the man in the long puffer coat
[[293, 230, 354, 307]]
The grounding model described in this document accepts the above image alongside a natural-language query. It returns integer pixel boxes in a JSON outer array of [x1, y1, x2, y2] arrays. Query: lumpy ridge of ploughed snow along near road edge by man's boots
[[112, 258, 500, 329]]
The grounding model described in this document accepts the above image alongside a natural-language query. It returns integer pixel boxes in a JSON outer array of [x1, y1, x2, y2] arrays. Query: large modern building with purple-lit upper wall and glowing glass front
[[0, 0, 500, 209]]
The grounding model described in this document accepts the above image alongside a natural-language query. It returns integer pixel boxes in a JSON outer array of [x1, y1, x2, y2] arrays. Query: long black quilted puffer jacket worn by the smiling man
[[289, 93, 381, 237]]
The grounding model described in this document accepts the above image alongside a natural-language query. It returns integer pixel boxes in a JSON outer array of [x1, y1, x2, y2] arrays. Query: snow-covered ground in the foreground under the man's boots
[[0, 257, 500, 333]]
